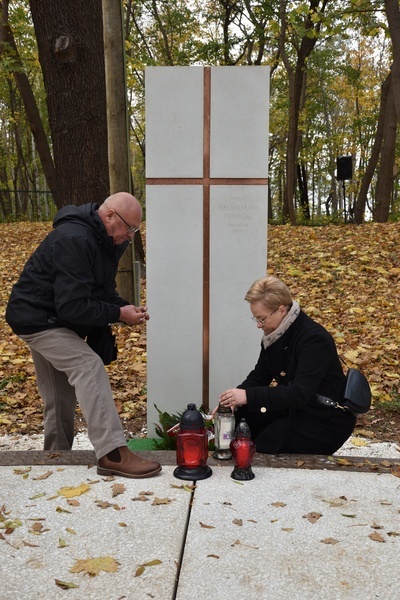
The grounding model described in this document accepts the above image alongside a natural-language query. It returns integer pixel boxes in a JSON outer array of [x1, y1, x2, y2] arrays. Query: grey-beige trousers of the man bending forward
[[19, 327, 126, 458]]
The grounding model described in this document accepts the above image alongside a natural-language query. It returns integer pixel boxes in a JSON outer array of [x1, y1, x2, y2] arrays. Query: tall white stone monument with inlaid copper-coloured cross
[[145, 67, 269, 437]]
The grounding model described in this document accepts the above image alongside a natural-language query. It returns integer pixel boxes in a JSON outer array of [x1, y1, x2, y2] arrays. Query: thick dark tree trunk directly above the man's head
[[30, 0, 109, 206]]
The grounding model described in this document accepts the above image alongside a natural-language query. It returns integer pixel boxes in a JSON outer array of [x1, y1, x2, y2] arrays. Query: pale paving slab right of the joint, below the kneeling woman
[[176, 466, 400, 600]]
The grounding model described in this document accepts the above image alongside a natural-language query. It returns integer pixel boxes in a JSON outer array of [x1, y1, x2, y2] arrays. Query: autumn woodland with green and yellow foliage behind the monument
[[0, 0, 400, 224]]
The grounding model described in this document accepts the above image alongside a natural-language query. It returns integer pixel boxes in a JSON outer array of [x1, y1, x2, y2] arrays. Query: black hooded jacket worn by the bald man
[[6, 204, 128, 337]]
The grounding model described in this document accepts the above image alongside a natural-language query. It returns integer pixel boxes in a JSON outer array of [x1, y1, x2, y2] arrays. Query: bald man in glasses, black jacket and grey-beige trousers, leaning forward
[[6, 192, 161, 478]]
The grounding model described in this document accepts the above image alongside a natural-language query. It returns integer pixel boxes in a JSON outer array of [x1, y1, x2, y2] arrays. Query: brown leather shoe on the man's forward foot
[[97, 446, 161, 479]]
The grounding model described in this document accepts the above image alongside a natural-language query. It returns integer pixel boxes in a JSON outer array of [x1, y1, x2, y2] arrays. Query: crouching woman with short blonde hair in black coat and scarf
[[220, 276, 356, 454]]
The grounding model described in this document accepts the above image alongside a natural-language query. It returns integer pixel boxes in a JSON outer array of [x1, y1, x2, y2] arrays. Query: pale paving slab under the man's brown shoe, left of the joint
[[0, 466, 191, 600]]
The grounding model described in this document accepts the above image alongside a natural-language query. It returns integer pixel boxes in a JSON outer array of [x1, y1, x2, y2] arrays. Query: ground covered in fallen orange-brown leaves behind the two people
[[0, 223, 400, 441]]
